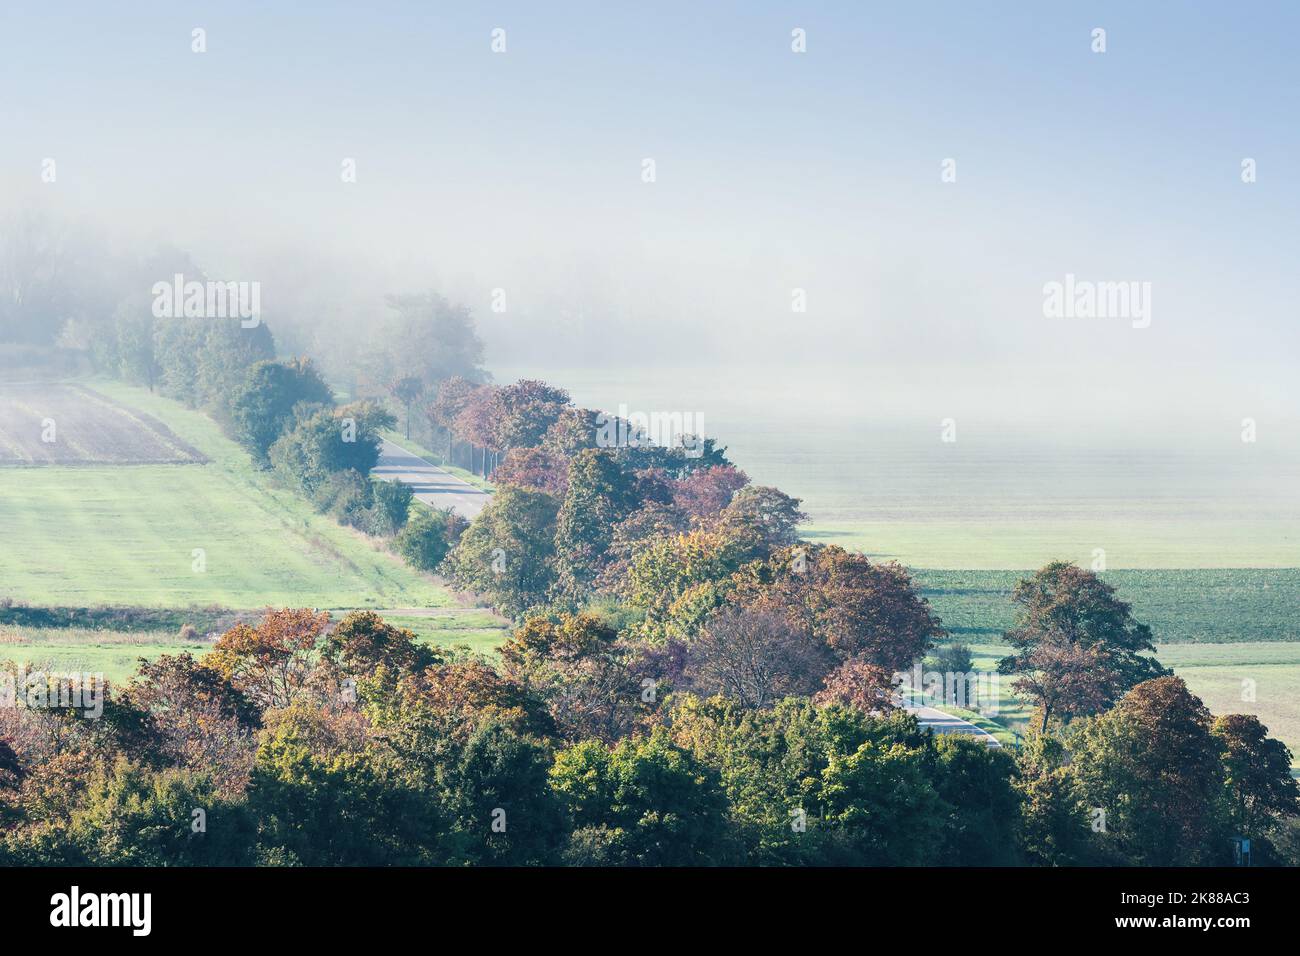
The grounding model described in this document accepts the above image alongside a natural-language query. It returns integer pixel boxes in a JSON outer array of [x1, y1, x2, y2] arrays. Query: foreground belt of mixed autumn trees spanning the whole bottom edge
[[0, 610, 1300, 865]]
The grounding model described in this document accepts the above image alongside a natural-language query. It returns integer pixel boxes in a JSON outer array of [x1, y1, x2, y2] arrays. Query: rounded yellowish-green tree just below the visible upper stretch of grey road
[[447, 485, 559, 617]]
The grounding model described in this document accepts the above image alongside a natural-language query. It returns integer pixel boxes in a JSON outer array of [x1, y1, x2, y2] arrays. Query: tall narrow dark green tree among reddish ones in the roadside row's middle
[[555, 449, 640, 604]]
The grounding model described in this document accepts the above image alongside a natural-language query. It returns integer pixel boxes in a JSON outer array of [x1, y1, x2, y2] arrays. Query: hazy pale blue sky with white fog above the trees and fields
[[0, 0, 1300, 421]]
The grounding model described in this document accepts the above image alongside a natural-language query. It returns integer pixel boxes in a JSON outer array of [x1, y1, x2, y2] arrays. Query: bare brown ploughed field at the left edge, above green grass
[[0, 382, 207, 466]]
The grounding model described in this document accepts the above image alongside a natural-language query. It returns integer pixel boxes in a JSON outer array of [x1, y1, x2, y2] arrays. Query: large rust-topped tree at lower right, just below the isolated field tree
[[1069, 676, 1229, 866]]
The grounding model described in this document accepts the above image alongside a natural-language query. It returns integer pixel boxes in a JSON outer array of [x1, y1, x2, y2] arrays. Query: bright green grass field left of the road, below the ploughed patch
[[0, 381, 454, 609]]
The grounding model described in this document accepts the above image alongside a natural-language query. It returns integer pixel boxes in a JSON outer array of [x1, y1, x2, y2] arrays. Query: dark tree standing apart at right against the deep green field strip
[[998, 561, 1169, 727]]
